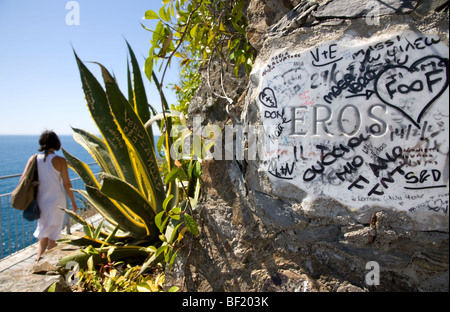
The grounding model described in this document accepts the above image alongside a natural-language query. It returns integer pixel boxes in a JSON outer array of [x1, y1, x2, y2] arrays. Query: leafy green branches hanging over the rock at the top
[[143, 0, 256, 114]]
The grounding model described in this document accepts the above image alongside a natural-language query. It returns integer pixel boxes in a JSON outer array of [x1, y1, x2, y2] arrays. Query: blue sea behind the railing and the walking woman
[[0, 135, 158, 259]]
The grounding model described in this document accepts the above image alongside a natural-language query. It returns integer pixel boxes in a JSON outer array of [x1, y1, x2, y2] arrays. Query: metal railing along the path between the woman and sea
[[0, 167, 98, 259]]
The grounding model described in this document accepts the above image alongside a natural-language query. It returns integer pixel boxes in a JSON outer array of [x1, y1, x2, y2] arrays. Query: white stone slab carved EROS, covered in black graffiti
[[258, 32, 450, 214]]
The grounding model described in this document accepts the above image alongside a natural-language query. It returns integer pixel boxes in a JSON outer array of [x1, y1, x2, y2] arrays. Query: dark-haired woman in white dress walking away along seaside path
[[20, 131, 77, 262]]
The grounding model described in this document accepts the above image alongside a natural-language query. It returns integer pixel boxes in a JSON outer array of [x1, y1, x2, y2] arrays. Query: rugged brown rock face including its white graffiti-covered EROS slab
[[170, 0, 449, 291]]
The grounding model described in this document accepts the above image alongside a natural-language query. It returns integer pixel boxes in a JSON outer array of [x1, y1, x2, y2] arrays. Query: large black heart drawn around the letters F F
[[375, 55, 449, 129]]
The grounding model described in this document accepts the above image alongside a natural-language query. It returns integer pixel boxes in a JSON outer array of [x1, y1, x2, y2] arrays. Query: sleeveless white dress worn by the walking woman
[[33, 154, 67, 241]]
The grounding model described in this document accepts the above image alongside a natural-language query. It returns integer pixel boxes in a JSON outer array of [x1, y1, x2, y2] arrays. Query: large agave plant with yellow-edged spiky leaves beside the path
[[60, 46, 199, 278]]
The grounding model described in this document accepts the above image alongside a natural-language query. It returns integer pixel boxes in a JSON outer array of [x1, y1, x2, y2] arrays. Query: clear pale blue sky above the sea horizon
[[0, 0, 179, 135]]
